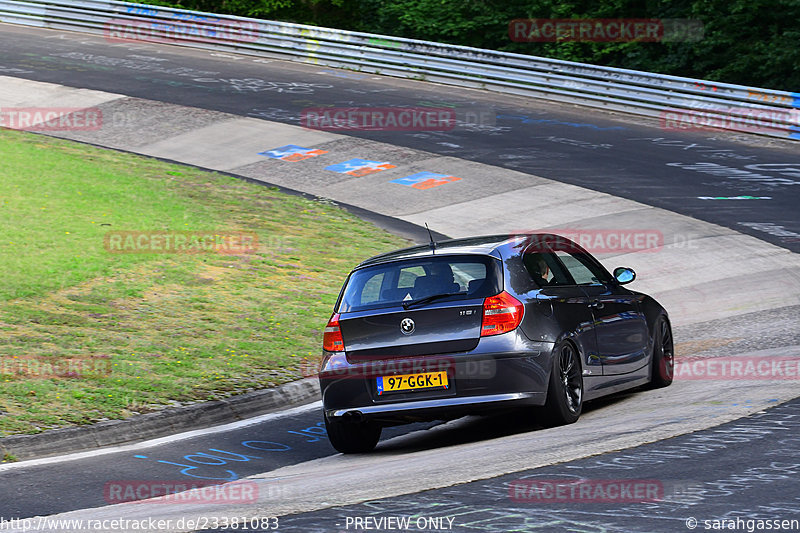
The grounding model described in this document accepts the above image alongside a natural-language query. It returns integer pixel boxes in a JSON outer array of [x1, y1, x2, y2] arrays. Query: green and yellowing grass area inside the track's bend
[[0, 131, 407, 436]]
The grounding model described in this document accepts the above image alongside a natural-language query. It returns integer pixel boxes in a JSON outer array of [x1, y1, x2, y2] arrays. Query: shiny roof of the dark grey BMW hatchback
[[355, 233, 564, 270]]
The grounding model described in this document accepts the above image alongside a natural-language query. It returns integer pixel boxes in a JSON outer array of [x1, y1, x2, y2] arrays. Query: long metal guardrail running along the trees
[[0, 0, 800, 139]]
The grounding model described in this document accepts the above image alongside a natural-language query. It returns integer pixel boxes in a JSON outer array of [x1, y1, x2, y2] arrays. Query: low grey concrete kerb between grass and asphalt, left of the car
[[0, 378, 319, 460]]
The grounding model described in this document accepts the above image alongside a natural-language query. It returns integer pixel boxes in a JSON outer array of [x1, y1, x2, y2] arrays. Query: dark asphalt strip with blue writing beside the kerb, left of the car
[[0, 402, 435, 518]]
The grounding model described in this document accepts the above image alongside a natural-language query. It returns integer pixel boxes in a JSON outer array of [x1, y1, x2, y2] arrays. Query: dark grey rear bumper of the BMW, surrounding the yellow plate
[[319, 330, 553, 424]]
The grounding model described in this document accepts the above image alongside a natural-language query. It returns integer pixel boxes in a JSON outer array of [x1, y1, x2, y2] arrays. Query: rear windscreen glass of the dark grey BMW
[[338, 256, 502, 313]]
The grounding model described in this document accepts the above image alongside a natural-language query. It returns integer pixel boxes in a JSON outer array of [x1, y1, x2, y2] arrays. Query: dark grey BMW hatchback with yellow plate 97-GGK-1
[[319, 234, 673, 453]]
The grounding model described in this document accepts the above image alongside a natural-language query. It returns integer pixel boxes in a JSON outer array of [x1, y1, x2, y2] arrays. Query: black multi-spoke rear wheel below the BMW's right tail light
[[541, 341, 583, 426]]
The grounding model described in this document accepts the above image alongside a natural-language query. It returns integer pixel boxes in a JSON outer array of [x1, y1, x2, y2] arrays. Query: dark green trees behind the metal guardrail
[[120, 0, 800, 91]]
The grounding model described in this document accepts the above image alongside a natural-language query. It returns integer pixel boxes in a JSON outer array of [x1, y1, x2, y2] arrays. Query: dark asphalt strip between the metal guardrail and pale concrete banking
[[0, 25, 800, 252]]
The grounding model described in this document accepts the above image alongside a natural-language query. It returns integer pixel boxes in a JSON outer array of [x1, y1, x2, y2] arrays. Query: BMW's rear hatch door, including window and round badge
[[338, 255, 502, 362]]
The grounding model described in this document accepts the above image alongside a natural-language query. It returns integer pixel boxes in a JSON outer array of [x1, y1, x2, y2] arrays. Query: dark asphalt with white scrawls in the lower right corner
[[223, 394, 800, 533]]
